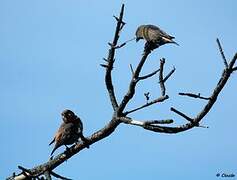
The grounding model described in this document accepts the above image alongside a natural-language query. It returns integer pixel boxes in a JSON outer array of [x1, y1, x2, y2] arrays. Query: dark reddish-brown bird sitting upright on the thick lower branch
[[49, 109, 89, 155]]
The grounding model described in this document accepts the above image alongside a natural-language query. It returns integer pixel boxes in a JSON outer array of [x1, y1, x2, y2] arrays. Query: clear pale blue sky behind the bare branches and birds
[[0, 0, 237, 180]]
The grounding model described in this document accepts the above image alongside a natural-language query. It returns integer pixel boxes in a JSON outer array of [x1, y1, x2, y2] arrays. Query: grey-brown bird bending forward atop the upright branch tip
[[136, 25, 179, 47]]
